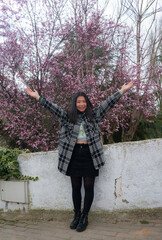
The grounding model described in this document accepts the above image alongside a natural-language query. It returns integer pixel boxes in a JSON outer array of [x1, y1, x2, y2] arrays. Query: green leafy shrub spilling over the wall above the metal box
[[0, 147, 38, 181]]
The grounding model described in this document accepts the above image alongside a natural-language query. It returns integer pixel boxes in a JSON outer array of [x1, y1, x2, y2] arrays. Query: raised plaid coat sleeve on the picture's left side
[[39, 96, 67, 121]]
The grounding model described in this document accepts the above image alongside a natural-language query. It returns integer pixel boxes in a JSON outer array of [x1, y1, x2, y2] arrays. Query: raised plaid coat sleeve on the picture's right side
[[93, 91, 122, 123]]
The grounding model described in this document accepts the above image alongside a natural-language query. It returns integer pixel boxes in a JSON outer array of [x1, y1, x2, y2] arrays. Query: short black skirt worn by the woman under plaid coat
[[66, 144, 99, 177]]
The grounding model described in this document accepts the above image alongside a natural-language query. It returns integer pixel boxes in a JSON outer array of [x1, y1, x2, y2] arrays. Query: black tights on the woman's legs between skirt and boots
[[71, 177, 95, 214]]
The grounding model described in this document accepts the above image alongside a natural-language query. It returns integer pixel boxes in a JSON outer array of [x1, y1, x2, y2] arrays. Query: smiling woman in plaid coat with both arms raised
[[26, 81, 133, 232]]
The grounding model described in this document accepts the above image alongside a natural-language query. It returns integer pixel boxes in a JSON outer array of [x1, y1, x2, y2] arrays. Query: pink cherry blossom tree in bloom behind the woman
[[0, 0, 161, 151]]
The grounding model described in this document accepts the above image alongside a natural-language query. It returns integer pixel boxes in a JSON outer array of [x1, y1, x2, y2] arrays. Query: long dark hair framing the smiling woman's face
[[68, 92, 93, 124]]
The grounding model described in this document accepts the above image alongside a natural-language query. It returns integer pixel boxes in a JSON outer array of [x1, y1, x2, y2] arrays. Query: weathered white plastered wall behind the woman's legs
[[0, 139, 162, 210]]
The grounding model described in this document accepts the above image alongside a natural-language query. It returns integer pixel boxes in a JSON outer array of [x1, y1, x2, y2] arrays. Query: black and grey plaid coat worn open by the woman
[[39, 91, 121, 174]]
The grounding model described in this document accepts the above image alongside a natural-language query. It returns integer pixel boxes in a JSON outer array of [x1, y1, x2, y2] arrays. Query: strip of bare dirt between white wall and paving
[[0, 208, 162, 224]]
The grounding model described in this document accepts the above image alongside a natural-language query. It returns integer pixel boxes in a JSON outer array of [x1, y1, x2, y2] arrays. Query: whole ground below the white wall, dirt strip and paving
[[0, 209, 162, 240]]
